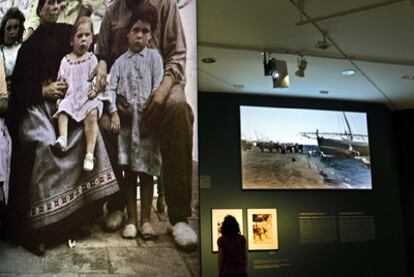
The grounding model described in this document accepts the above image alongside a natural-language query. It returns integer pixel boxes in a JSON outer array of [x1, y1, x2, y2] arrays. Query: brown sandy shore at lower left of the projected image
[[242, 151, 338, 189]]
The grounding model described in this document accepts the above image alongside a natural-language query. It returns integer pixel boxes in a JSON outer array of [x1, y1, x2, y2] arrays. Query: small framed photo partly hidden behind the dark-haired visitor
[[211, 209, 243, 252]]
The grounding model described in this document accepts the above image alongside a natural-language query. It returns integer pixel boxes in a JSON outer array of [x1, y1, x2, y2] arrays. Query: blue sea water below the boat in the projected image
[[303, 145, 372, 189]]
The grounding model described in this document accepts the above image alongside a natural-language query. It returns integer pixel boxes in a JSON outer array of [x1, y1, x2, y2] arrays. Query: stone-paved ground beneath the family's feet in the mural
[[0, 162, 200, 277]]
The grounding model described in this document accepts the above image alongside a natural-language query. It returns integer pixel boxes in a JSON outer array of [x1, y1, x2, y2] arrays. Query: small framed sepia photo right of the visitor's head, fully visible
[[247, 209, 279, 250]]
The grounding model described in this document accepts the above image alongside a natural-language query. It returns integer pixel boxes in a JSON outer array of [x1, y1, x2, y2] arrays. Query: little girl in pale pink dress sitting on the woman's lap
[[54, 17, 103, 171]]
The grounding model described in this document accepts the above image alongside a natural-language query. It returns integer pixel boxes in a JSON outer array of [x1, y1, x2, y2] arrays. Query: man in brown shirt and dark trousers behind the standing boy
[[96, 0, 198, 249]]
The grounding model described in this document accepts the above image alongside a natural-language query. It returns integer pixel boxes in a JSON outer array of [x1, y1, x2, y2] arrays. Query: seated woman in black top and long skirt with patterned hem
[[6, 0, 118, 254]]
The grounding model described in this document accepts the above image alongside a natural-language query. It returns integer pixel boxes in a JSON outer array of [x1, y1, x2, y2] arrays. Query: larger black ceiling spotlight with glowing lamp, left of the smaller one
[[262, 52, 289, 88]]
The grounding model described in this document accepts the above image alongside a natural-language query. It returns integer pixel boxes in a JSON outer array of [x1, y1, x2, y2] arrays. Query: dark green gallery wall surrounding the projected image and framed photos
[[198, 92, 406, 277]]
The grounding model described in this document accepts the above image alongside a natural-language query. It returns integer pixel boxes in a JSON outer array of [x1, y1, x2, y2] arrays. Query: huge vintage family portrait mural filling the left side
[[0, 0, 199, 276]]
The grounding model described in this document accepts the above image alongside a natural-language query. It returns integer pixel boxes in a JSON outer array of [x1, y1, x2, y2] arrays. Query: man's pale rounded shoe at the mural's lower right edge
[[168, 221, 198, 251]]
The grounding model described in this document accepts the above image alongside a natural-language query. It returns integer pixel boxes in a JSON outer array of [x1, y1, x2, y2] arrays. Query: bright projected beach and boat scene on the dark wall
[[240, 106, 372, 189]]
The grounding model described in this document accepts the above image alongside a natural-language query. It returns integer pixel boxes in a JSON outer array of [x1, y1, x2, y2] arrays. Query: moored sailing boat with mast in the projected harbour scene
[[301, 112, 369, 157]]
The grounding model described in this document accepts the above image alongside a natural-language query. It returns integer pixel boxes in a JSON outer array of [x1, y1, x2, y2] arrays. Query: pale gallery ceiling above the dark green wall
[[197, 0, 414, 110]]
